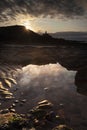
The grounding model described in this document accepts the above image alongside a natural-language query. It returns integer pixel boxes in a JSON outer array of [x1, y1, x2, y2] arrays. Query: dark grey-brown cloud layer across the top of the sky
[[0, 0, 87, 21]]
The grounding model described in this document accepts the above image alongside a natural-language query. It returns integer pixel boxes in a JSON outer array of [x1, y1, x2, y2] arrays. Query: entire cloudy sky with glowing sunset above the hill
[[0, 0, 87, 32]]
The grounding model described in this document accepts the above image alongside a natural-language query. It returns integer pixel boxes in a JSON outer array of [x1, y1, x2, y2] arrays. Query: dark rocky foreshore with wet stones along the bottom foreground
[[0, 100, 73, 130]]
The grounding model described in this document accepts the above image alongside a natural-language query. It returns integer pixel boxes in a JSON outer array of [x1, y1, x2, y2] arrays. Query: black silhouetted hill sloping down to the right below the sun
[[0, 25, 83, 45]]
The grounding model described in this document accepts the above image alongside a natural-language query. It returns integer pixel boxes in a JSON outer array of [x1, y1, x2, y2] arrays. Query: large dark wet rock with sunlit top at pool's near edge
[[28, 100, 56, 126]]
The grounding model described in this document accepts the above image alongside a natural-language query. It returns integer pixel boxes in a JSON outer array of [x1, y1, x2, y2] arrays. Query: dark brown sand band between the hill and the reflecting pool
[[0, 45, 87, 95]]
